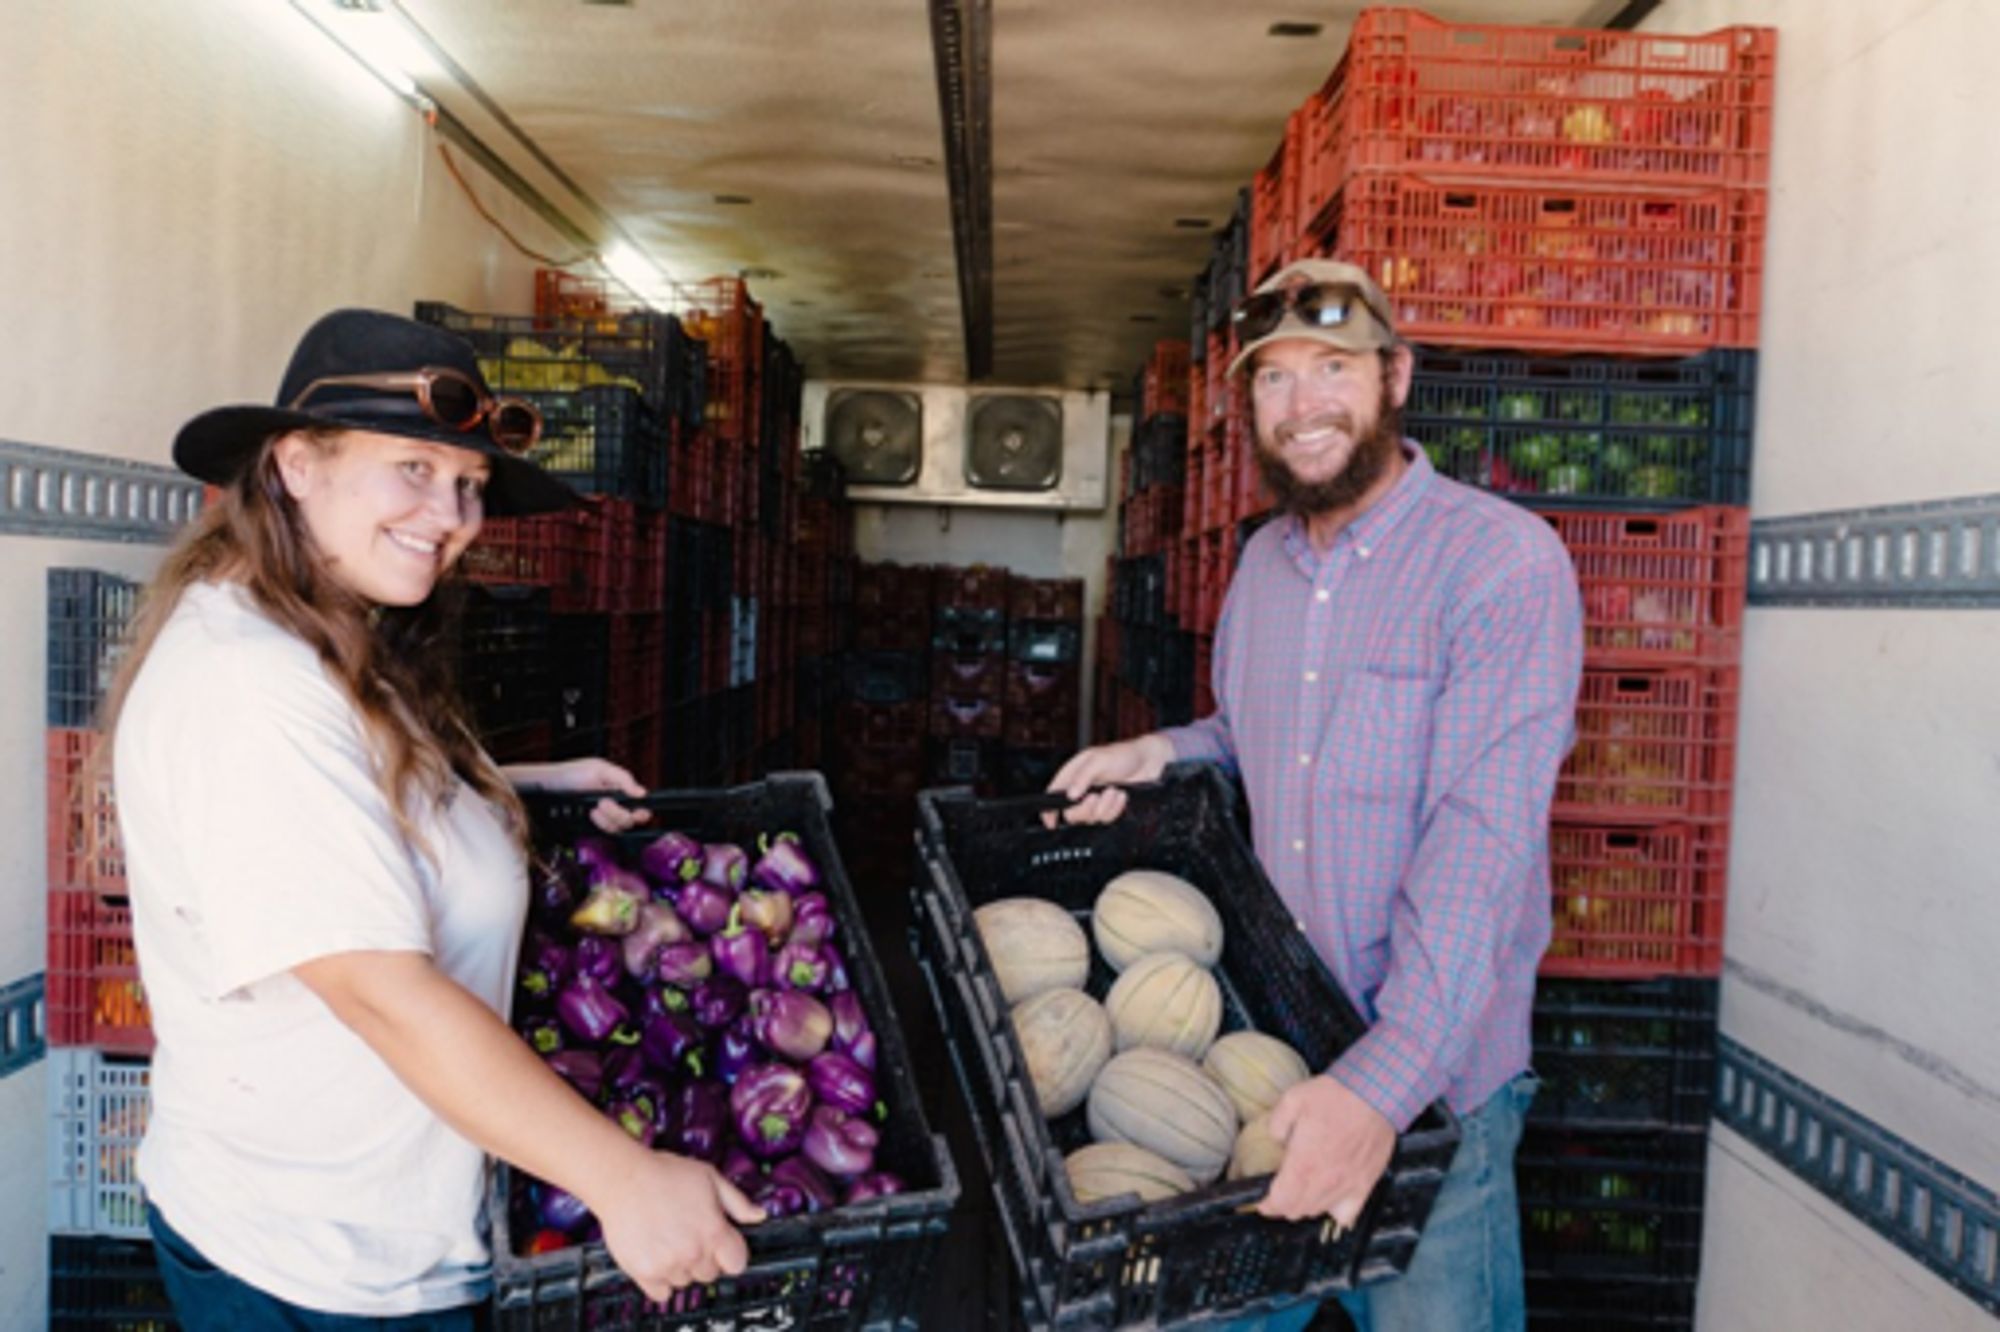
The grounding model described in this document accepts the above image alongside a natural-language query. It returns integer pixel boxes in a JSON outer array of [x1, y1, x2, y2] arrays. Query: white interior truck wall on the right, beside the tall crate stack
[[1644, 0, 2000, 1332]]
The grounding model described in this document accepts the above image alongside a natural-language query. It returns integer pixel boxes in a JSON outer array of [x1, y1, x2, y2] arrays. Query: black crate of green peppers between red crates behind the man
[[1404, 348, 1756, 508]]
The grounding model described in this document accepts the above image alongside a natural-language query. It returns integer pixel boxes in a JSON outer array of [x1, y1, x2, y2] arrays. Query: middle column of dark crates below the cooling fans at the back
[[930, 564, 1008, 790]]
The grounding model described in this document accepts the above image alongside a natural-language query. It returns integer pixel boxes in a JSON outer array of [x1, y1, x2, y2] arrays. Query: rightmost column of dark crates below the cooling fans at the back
[[996, 576, 1084, 796]]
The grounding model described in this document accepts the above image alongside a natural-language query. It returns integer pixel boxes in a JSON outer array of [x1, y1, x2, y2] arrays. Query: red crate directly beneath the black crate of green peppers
[[1542, 506, 1750, 666]]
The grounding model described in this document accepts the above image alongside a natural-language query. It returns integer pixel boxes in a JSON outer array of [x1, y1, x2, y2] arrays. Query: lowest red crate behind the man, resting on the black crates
[[1542, 820, 1730, 980]]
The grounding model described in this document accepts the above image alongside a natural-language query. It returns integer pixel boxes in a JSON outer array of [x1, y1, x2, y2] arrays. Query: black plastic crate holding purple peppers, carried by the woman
[[490, 772, 958, 1332]]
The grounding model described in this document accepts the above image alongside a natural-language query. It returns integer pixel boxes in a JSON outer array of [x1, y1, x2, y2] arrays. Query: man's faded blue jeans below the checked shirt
[[1202, 1074, 1540, 1332]]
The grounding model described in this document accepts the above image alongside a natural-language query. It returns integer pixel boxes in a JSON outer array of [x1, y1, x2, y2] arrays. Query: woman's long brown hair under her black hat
[[98, 430, 528, 854]]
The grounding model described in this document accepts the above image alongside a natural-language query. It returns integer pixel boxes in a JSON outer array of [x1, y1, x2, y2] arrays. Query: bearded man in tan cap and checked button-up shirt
[[1050, 260, 1582, 1332]]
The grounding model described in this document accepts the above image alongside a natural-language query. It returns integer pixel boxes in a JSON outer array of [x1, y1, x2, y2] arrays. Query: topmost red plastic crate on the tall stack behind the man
[[1302, 8, 1778, 210]]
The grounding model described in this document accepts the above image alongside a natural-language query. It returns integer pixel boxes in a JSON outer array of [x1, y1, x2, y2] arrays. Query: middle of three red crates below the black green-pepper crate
[[1554, 666, 1740, 820]]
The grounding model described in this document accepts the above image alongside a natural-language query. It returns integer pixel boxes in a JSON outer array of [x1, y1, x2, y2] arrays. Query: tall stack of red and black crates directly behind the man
[[1136, 10, 1776, 1328]]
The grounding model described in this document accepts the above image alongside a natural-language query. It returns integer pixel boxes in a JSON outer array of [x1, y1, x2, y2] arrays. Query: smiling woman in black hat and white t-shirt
[[106, 310, 762, 1332]]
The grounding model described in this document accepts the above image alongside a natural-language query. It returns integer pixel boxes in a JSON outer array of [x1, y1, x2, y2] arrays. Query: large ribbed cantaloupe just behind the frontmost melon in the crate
[[1088, 1048, 1236, 1184]]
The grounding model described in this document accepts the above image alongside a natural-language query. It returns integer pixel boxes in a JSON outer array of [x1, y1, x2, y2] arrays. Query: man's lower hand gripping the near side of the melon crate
[[1258, 1076, 1396, 1228]]
